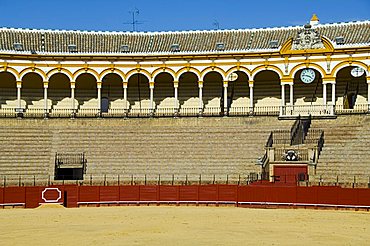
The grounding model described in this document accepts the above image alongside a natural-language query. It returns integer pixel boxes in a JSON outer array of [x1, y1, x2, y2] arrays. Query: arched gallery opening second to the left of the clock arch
[[227, 71, 250, 115]]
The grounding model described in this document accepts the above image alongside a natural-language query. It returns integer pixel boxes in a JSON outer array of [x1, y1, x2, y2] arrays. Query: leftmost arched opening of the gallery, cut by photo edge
[[0, 72, 17, 115]]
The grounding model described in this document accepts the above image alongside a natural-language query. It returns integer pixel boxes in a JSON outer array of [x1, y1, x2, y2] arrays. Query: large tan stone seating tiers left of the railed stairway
[[0, 117, 291, 183]]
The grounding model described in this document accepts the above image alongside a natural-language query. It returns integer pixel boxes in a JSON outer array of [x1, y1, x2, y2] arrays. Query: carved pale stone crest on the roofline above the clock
[[292, 25, 325, 50]]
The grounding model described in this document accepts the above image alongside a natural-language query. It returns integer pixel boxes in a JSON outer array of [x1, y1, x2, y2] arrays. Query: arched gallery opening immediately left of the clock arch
[[253, 70, 280, 115]]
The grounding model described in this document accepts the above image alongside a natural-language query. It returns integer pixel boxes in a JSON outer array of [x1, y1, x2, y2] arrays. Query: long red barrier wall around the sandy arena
[[0, 185, 370, 208]]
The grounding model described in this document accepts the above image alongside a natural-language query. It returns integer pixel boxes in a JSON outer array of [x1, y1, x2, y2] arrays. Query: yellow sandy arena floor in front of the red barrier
[[0, 206, 370, 245]]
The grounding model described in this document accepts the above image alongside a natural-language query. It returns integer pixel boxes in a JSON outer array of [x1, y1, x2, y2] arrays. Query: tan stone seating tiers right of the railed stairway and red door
[[312, 115, 370, 183]]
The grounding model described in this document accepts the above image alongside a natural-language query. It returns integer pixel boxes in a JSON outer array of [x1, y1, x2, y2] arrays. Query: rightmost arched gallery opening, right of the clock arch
[[335, 66, 368, 112]]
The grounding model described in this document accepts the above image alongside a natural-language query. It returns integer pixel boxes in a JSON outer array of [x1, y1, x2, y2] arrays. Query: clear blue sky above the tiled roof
[[0, 0, 370, 31]]
